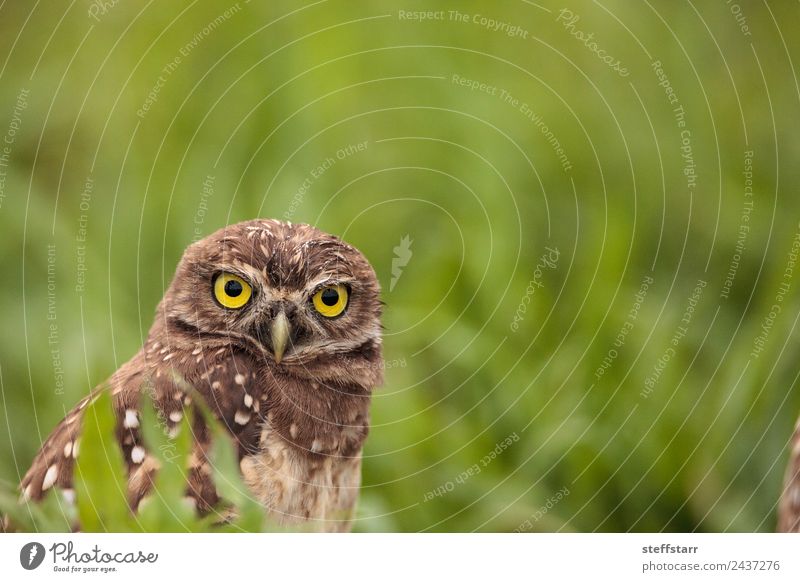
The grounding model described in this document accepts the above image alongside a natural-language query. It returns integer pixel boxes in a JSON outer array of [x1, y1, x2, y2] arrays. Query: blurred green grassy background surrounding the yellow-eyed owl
[[0, 0, 800, 531]]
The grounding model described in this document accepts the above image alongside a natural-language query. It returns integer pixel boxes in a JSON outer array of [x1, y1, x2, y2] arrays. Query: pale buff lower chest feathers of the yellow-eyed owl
[[241, 425, 361, 531]]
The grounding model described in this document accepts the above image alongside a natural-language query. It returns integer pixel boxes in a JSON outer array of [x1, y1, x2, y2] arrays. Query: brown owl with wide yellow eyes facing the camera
[[20, 220, 383, 531]]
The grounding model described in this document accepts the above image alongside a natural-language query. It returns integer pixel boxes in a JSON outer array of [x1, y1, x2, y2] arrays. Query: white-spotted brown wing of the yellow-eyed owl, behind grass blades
[[20, 342, 264, 511]]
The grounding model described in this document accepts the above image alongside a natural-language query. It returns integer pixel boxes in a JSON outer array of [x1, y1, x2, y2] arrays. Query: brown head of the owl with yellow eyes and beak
[[162, 220, 381, 367]]
